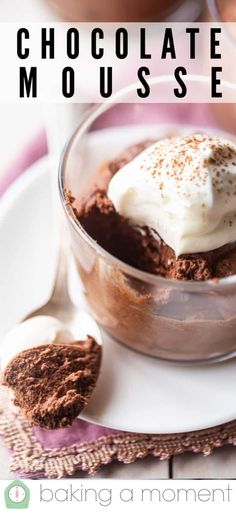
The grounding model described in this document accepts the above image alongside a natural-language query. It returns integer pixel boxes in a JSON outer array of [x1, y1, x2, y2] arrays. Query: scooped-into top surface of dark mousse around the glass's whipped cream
[[67, 140, 236, 281]]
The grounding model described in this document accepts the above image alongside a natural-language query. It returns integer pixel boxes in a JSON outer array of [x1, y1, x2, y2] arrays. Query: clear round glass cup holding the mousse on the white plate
[[59, 76, 236, 363]]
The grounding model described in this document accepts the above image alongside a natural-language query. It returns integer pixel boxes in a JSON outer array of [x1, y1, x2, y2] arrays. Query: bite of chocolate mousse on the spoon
[[3, 336, 101, 430]]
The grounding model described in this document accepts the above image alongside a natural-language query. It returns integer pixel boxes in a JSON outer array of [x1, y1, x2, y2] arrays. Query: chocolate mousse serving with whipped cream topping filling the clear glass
[[65, 134, 236, 361]]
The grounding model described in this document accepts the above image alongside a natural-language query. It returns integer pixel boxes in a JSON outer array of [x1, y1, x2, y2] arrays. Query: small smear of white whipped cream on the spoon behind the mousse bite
[[0, 315, 73, 369]]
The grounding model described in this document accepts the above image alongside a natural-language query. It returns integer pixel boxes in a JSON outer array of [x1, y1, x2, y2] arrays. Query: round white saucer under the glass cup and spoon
[[0, 158, 236, 433]]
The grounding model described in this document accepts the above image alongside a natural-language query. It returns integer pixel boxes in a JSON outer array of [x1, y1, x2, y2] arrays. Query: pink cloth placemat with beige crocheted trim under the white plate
[[0, 105, 236, 478]]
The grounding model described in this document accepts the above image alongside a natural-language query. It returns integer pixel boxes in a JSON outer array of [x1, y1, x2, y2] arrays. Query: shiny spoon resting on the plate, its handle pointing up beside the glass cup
[[0, 223, 102, 382]]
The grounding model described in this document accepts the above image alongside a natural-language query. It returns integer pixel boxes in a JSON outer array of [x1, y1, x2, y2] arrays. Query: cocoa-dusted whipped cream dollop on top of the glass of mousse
[[108, 134, 236, 256]]
